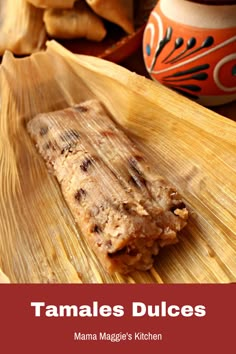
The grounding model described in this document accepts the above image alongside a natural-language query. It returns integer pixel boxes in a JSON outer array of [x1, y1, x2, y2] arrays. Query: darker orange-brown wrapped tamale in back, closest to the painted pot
[[86, 0, 134, 33]]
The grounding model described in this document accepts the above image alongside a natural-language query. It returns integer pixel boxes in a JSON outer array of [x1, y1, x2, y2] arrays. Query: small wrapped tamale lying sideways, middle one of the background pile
[[43, 1, 106, 42]]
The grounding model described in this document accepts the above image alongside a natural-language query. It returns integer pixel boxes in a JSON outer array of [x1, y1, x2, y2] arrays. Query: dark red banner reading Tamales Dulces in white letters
[[0, 284, 236, 354]]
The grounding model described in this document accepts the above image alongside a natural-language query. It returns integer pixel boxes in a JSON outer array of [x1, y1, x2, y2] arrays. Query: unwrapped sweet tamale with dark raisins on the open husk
[[27, 100, 188, 273]]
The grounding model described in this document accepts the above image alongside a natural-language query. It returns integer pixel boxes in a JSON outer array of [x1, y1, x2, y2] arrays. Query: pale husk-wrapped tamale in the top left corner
[[0, 0, 46, 55]]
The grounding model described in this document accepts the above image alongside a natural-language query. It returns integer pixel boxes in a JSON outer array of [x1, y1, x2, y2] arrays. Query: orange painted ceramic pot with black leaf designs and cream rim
[[143, 0, 236, 106]]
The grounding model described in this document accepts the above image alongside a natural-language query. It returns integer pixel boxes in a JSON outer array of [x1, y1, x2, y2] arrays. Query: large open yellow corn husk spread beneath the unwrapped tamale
[[0, 41, 236, 283]]
